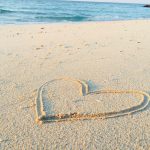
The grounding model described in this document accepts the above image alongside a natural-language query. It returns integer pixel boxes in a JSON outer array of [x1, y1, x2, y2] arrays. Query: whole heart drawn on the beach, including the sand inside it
[[36, 77, 150, 123]]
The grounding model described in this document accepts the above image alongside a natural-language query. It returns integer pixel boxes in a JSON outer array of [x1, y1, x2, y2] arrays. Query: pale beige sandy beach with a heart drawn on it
[[0, 20, 150, 150]]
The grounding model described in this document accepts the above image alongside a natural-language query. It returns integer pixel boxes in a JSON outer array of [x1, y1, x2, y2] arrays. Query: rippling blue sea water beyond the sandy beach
[[0, 0, 150, 24]]
